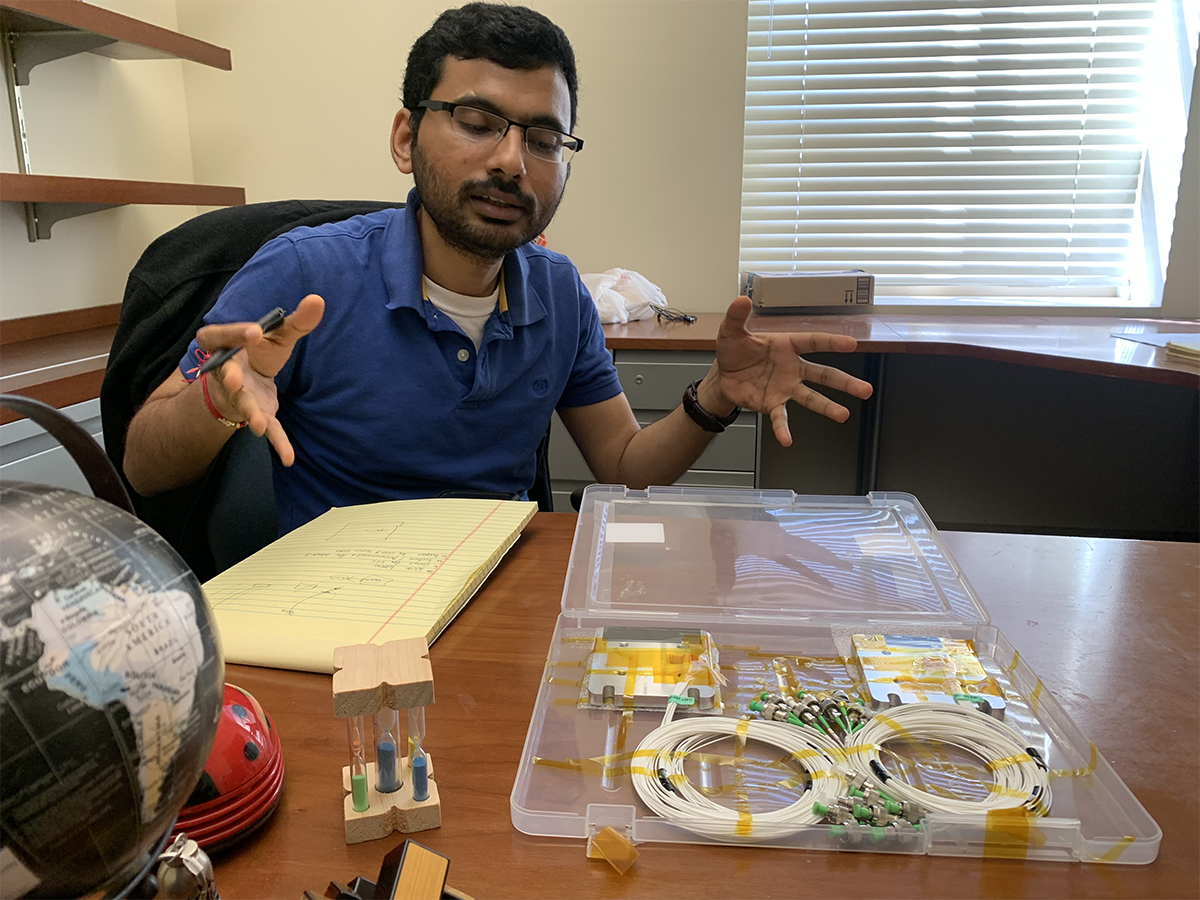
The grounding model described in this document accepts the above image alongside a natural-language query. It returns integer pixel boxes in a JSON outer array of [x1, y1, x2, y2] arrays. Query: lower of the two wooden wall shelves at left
[[0, 173, 246, 240]]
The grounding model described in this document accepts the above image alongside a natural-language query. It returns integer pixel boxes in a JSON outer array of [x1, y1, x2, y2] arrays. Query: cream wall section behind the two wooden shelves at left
[[0, 0, 196, 320]]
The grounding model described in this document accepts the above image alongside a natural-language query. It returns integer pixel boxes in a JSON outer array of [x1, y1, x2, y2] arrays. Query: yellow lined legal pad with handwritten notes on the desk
[[204, 499, 538, 672]]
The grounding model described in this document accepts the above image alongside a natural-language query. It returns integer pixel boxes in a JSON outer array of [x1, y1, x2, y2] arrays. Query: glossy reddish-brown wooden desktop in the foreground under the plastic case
[[216, 514, 1200, 900]]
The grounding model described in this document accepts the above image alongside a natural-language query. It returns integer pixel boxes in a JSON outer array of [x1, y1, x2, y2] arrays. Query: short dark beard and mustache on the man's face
[[413, 138, 563, 262]]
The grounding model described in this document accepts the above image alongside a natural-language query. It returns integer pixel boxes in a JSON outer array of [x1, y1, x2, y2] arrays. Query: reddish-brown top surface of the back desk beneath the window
[[604, 313, 1200, 389]]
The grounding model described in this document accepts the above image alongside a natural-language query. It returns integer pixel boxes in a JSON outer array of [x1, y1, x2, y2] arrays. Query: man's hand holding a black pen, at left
[[196, 294, 325, 466]]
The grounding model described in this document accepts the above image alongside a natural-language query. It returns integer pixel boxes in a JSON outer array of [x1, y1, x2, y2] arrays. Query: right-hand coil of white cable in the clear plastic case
[[846, 703, 1051, 816]]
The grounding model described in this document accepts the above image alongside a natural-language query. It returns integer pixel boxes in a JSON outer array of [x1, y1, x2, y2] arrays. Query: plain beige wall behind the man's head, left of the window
[[171, 0, 746, 311]]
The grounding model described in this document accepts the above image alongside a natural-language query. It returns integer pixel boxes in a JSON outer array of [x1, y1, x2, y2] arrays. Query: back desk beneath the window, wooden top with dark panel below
[[609, 313, 1200, 540]]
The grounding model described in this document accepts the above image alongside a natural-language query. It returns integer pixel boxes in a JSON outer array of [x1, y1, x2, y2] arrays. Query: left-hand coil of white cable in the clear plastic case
[[631, 709, 846, 841]]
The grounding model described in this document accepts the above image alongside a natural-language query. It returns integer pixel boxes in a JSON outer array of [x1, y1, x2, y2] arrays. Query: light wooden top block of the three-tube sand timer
[[334, 637, 433, 719]]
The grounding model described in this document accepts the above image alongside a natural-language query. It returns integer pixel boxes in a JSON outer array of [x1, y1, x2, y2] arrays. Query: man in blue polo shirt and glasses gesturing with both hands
[[125, 4, 871, 533]]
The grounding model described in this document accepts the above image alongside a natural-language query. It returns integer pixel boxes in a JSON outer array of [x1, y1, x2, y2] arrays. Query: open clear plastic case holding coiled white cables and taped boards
[[511, 494, 1162, 864]]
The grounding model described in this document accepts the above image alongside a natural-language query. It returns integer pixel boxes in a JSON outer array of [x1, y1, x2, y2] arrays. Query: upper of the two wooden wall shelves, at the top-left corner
[[0, 0, 233, 84]]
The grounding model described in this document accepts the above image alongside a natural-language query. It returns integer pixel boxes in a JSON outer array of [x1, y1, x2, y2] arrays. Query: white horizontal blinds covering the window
[[740, 0, 1153, 304]]
